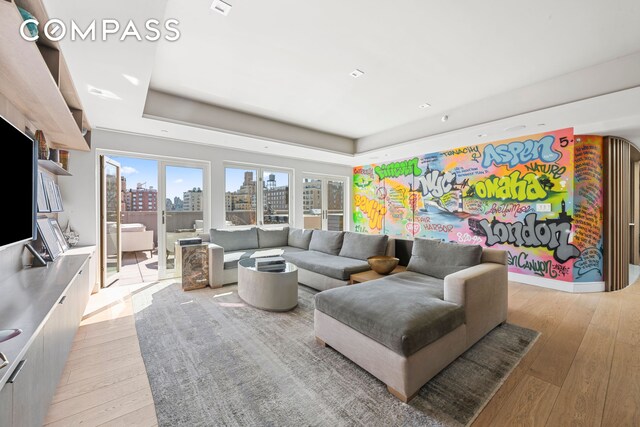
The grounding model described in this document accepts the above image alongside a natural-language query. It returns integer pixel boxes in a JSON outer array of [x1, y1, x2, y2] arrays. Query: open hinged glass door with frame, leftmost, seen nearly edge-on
[[100, 156, 122, 288]]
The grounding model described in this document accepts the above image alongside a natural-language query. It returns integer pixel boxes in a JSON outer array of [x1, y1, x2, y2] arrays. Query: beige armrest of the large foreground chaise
[[444, 262, 508, 346]]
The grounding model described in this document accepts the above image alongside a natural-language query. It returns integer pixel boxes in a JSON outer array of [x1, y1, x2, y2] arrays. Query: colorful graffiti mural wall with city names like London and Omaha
[[353, 129, 602, 282]]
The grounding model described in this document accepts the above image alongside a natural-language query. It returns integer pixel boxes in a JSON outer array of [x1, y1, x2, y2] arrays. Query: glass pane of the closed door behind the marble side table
[[161, 166, 206, 276]]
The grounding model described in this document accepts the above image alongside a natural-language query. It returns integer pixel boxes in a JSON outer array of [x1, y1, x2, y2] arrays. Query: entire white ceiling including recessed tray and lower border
[[45, 0, 640, 165]]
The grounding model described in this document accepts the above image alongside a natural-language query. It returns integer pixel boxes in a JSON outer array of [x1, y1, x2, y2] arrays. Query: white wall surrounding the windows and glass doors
[[59, 130, 352, 245]]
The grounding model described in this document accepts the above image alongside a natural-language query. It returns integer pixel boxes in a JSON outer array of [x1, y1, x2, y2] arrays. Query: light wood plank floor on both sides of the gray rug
[[46, 283, 640, 427]]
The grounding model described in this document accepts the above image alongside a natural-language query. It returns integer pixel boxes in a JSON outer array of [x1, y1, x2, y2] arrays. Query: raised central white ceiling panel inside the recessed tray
[[151, 0, 640, 139]]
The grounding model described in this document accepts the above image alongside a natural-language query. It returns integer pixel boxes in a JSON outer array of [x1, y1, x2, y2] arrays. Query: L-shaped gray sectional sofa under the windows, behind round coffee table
[[201, 227, 394, 291]]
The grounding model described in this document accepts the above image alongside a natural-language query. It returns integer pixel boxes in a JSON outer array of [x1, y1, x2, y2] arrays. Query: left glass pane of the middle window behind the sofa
[[225, 168, 258, 226]]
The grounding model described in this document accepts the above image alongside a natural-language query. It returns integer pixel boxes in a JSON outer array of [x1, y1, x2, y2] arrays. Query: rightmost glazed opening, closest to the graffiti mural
[[302, 176, 347, 231]]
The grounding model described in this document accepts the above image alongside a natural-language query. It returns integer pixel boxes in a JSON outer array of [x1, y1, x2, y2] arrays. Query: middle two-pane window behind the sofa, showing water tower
[[224, 167, 291, 226]]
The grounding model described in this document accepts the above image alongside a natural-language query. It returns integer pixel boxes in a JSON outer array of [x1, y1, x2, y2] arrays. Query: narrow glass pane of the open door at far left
[[104, 163, 120, 284]]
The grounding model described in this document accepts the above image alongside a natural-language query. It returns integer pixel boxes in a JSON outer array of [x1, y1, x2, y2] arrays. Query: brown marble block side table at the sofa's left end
[[175, 243, 209, 291]]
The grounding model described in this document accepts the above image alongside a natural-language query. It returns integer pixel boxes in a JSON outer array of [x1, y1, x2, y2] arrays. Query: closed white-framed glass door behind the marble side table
[[158, 162, 210, 279]]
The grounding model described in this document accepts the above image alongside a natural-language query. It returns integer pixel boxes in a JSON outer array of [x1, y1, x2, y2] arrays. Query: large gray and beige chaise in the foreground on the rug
[[314, 239, 507, 402]]
